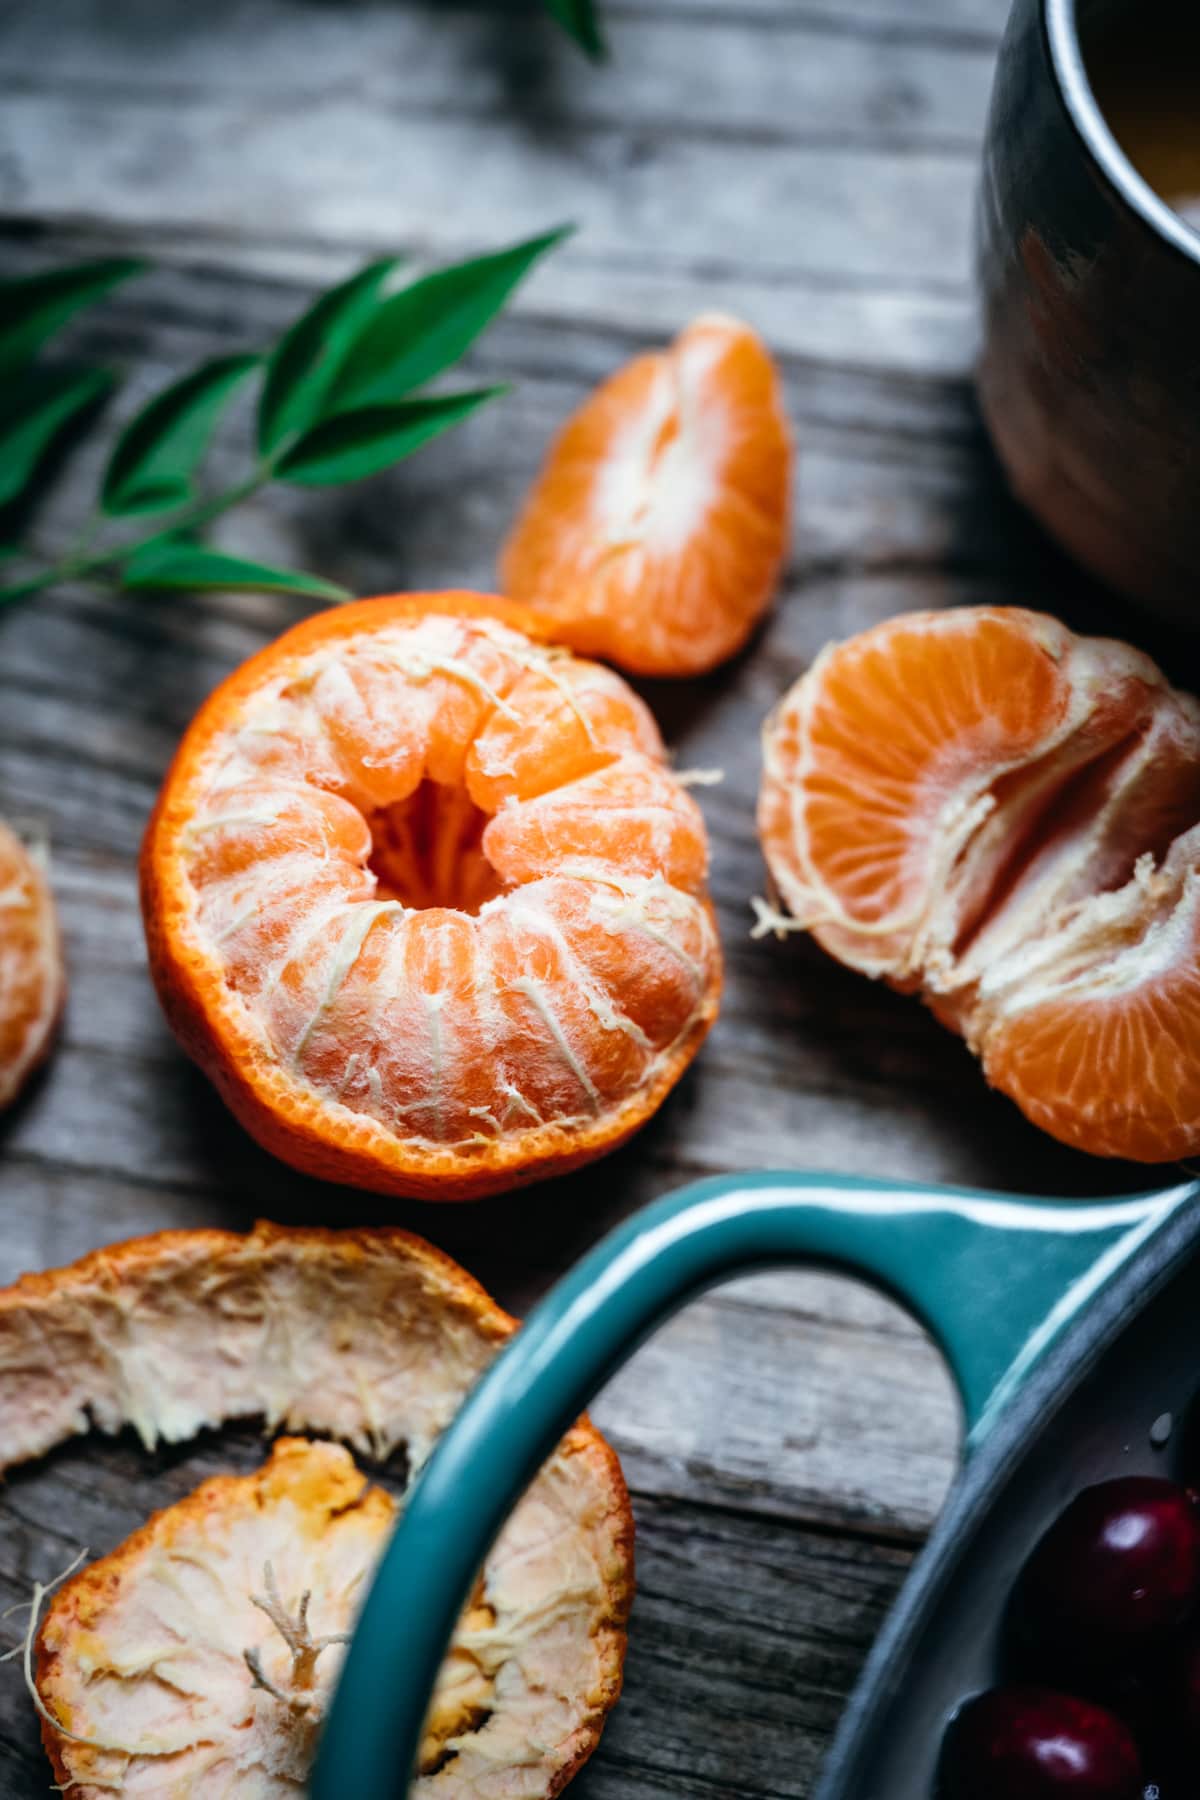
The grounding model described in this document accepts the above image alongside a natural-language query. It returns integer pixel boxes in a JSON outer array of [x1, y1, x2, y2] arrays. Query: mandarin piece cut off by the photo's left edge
[[0, 819, 67, 1107]]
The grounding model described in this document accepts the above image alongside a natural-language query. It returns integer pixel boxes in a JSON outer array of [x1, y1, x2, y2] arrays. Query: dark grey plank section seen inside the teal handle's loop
[[576, 1494, 909, 1800]]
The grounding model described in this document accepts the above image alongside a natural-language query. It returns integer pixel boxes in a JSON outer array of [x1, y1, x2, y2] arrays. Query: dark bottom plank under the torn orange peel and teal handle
[[0, 1431, 909, 1800]]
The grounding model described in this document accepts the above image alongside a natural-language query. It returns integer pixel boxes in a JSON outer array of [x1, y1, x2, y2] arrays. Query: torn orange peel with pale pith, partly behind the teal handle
[[0, 1226, 633, 1800]]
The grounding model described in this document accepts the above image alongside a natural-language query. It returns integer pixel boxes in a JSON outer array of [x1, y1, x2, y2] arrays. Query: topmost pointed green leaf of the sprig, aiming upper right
[[326, 225, 572, 414]]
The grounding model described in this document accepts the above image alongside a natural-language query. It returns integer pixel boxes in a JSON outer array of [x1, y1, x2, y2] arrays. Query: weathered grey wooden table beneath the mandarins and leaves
[[0, 0, 1173, 1800]]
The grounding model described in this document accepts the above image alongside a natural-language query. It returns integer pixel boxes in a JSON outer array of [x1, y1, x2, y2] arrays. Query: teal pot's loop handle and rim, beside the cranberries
[[311, 1174, 1200, 1800]]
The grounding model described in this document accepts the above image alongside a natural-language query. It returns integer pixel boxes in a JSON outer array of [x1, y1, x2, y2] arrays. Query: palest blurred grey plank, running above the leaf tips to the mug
[[0, 90, 975, 282]]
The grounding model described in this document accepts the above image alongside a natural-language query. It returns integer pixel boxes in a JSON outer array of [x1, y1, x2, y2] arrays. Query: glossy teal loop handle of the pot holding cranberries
[[311, 1174, 1196, 1800]]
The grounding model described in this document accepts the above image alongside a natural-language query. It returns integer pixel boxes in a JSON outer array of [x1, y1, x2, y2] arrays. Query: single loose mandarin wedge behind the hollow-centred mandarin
[[500, 315, 792, 675]]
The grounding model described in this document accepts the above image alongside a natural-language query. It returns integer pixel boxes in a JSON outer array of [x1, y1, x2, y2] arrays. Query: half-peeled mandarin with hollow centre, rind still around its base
[[142, 594, 720, 1199]]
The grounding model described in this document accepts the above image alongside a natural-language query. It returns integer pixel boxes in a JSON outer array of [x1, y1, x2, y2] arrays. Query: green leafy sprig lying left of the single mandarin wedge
[[0, 229, 567, 603]]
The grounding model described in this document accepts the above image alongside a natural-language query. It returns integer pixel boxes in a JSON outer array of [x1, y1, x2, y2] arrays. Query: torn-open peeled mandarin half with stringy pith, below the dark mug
[[759, 607, 1200, 1163]]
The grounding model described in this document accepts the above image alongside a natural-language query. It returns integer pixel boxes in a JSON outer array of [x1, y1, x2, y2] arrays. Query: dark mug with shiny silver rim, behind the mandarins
[[979, 0, 1200, 617]]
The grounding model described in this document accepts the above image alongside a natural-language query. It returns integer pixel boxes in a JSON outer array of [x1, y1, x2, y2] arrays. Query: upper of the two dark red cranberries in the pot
[[1016, 1476, 1200, 1669]]
